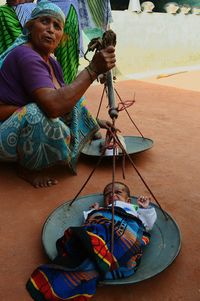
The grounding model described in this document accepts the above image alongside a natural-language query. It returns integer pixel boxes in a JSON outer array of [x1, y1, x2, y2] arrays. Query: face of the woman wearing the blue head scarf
[[28, 16, 64, 55]]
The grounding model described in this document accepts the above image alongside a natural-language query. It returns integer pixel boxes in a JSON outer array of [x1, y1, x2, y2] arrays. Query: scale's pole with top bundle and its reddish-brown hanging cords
[[69, 30, 168, 254]]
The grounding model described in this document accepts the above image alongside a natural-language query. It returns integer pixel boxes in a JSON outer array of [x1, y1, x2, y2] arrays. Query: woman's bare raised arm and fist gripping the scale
[[33, 46, 116, 118]]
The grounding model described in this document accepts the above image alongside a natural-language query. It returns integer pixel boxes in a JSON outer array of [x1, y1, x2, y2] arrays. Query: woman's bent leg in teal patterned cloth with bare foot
[[0, 104, 70, 187]]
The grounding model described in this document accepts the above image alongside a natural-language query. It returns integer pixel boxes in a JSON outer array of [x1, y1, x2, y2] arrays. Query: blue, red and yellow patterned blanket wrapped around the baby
[[27, 208, 150, 301]]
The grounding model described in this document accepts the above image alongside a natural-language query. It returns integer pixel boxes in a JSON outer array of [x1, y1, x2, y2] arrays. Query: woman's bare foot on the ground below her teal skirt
[[18, 166, 58, 188]]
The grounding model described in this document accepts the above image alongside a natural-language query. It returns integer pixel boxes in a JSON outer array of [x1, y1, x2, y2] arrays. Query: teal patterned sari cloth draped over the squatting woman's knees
[[0, 99, 99, 173]]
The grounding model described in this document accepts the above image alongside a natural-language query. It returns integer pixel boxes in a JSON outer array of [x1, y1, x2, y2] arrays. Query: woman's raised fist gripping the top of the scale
[[89, 46, 116, 75]]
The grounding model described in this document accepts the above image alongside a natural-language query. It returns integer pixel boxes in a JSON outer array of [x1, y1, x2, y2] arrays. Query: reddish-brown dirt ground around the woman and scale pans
[[0, 73, 200, 301]]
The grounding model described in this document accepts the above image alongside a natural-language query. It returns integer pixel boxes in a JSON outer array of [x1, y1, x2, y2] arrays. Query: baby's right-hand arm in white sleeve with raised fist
[[137, 196, 157, 231]]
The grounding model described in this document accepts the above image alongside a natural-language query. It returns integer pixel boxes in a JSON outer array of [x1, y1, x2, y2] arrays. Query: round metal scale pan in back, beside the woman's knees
[[82, 136, 153, 157]]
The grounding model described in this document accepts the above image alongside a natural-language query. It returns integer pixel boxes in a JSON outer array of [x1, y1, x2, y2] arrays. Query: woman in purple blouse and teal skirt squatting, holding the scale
[[0, 1, 115, 187]]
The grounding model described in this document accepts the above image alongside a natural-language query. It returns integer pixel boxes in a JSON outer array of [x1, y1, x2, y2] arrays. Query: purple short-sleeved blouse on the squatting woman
[[0, 45, 65, 106]]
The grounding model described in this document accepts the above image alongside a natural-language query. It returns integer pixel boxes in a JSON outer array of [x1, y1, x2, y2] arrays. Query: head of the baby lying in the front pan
[[104, 184, 130, 207]]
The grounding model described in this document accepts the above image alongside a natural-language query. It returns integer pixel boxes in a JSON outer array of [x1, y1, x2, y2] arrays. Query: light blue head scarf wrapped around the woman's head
[[0, 0, 65, 68]]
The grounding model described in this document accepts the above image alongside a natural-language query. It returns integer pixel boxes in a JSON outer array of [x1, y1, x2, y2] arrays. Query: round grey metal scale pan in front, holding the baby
[[42, 194, 181, 285]]
